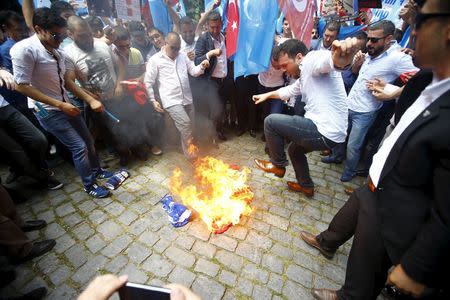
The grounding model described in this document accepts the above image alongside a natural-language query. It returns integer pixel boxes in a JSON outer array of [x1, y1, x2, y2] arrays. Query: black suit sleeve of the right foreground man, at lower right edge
[[400, 154, 450, 286]]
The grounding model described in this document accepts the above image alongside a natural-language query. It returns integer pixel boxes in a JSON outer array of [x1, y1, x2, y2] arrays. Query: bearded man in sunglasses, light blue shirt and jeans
[[322, 20, 418, 182]]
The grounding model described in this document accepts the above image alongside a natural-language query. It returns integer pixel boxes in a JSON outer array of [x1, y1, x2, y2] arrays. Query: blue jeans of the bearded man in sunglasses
[[342, 109, 378, 176]]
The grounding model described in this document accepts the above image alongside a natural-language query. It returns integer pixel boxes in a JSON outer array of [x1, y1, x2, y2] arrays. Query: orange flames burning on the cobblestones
[[170, 156, 253, 233]]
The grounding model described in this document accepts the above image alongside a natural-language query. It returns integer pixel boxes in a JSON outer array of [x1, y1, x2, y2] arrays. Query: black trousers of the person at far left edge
[[0, 105, 48, 181]]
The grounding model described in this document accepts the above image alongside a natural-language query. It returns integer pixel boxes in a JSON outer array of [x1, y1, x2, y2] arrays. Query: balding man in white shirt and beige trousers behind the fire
[[144, 32, 209, 159]]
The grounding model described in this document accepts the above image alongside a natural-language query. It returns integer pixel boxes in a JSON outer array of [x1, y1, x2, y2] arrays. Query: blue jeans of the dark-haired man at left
[[36, 110, 100, 187]]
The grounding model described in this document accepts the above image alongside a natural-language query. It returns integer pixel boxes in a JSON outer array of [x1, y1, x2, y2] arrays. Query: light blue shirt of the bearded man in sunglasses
[[348, 42, 419, 112]]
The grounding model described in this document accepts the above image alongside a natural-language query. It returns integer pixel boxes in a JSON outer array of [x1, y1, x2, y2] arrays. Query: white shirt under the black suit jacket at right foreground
[[369, 77, 450, 186]]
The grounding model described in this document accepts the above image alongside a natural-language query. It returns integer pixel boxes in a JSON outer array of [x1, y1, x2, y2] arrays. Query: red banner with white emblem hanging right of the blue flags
[[278, 0, 316, 48]]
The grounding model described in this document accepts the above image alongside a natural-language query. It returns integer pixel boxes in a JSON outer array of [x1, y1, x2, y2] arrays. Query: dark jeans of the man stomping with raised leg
[[264, 114, 336, 187]]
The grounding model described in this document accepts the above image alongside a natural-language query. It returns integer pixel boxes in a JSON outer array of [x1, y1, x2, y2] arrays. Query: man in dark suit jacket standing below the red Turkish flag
[[194, 11, 229, 142]]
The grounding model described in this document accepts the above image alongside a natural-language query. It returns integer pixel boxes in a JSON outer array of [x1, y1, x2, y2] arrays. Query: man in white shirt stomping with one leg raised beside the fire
[[253, 39, 356, 197]]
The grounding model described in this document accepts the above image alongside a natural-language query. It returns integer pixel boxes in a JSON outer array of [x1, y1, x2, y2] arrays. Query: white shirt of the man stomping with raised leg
[[278, 50, 348, 143]]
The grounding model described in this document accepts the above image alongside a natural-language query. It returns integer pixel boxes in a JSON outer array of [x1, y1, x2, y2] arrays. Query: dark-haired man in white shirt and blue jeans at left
[[11, 7, 109, 197]]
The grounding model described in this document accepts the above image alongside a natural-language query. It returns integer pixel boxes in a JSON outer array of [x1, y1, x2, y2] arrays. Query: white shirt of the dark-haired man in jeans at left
[[10, 34, 69, 110]]
